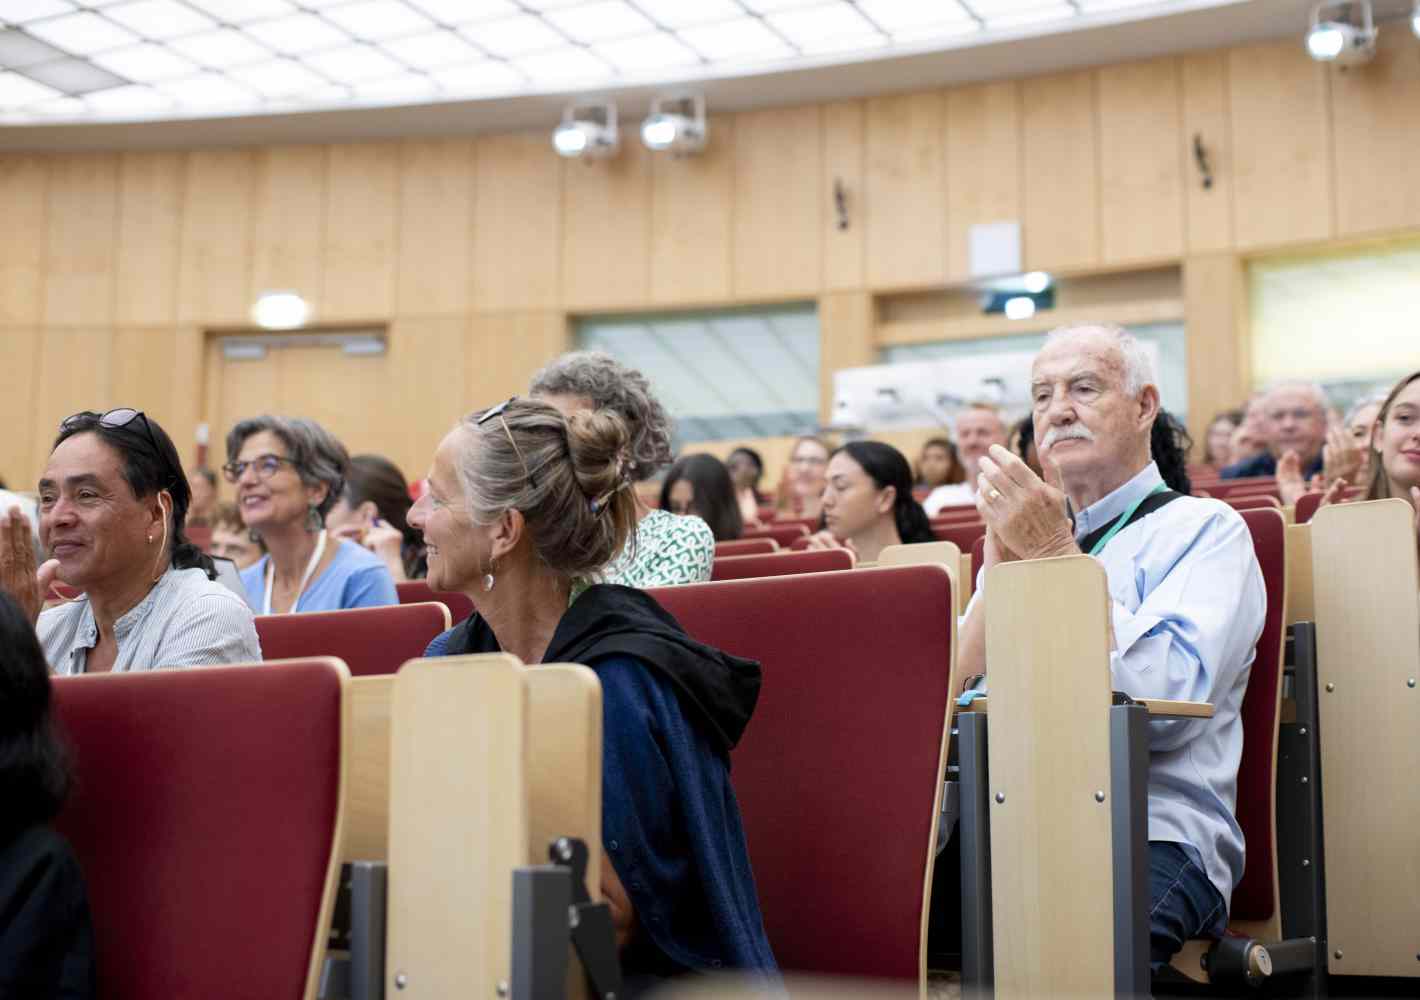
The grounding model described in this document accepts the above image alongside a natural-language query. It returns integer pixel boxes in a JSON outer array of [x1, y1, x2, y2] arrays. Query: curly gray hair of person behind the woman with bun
[[528, 351, 672, 480]]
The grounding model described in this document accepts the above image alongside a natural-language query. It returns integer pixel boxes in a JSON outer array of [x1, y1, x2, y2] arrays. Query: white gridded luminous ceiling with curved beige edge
[[0, 0, 1357, 148]]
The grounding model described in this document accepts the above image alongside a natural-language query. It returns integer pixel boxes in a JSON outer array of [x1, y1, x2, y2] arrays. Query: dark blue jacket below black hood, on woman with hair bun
[[425, 598, 777, 976]]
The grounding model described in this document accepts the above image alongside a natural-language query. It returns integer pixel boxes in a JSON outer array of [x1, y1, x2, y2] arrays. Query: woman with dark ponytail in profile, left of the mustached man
[[811, 440, 933, 563]]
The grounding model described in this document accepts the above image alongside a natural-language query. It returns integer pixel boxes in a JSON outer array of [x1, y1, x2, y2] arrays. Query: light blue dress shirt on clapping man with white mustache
[[977, 463, 1267, 902]]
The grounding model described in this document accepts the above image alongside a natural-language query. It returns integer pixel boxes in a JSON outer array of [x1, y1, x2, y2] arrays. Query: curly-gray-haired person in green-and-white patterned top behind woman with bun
[[531, 351, 714, 587]]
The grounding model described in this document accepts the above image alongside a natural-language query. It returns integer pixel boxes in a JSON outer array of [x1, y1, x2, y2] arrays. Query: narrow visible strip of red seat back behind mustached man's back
[[1230, 509, 1287, 920]]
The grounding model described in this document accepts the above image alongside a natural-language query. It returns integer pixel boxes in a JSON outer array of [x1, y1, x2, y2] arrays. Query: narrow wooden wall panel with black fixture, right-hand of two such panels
[[1180, 53, 1234, 253]]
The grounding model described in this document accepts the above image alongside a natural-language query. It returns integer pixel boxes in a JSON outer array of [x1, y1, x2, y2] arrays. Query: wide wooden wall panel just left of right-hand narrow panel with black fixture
[[1095, 58, 1184, 264]]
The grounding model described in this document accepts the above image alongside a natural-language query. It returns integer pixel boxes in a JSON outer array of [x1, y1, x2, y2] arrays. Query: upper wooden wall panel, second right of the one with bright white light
[[395, 139, 474, 315]]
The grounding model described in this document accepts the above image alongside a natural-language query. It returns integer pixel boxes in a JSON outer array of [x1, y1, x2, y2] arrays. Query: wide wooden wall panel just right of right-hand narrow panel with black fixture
[[1228, 38, 1333, 250]]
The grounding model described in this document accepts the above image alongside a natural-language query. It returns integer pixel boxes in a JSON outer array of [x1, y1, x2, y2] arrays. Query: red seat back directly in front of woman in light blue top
[[256, 602, 450, 678]]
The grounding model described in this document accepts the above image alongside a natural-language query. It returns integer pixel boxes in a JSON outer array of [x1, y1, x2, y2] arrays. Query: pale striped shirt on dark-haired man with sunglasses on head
[[36, 570, 261, 675]]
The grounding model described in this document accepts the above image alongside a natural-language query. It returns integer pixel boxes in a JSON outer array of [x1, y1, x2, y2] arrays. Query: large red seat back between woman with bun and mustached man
[[650, 557, 951, 980]]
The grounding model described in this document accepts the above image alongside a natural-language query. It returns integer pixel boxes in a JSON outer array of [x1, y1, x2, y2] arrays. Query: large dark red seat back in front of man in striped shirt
[[54, 659, 348, 1000]]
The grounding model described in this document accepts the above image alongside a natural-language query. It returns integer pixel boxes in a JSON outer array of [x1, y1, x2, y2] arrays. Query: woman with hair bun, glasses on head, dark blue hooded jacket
[[409, 399, 775, 996]]
